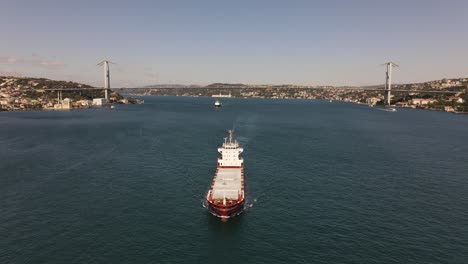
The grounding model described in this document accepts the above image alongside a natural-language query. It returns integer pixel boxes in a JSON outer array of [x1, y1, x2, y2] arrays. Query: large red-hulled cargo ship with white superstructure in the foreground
[[206, 130, 245, 218]]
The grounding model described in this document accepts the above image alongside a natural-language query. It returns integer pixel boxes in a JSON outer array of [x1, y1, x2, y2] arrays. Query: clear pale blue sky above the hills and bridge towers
[[0, 0, 468, 87]]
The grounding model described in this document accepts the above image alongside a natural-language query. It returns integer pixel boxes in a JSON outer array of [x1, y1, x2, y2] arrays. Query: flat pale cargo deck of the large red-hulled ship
[[211, 168, 243, 200]]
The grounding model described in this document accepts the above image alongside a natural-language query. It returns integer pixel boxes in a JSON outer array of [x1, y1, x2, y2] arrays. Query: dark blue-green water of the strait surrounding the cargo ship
[[0, 97, 468, 263]]
